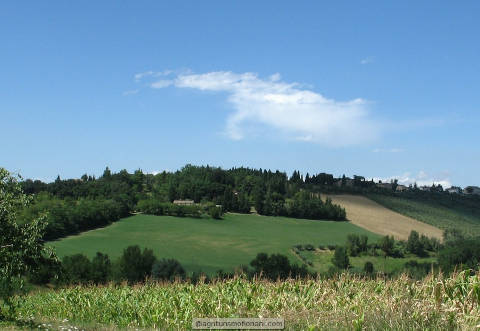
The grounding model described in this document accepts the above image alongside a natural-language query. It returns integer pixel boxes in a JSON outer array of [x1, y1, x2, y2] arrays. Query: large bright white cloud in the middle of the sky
[[148, 71, 381, 146]]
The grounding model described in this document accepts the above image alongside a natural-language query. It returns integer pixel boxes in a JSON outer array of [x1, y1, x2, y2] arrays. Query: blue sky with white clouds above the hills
[[0, 1, 480, 186]]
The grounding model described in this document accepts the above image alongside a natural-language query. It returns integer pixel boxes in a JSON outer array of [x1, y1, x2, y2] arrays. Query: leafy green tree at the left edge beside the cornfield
[[0, 168, 56, 320]]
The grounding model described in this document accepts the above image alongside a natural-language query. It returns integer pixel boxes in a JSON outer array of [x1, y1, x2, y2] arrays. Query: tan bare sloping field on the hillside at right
[[322, 194, 443, 239]]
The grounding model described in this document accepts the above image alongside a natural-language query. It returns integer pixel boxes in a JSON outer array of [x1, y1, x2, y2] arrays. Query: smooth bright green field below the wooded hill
[[50, 214, 378, 274]]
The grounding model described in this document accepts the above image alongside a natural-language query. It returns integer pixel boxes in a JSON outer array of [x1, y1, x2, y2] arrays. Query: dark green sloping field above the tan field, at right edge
[[367, 194, 480, 236]]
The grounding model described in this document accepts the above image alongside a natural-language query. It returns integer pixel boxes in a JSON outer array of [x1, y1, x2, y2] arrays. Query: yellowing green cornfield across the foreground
[[13, 271, 480, 330]]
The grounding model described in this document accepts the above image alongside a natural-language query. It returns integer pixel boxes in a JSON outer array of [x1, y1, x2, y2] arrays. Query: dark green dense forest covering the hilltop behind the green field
[[21, 165, 480, 240]]
